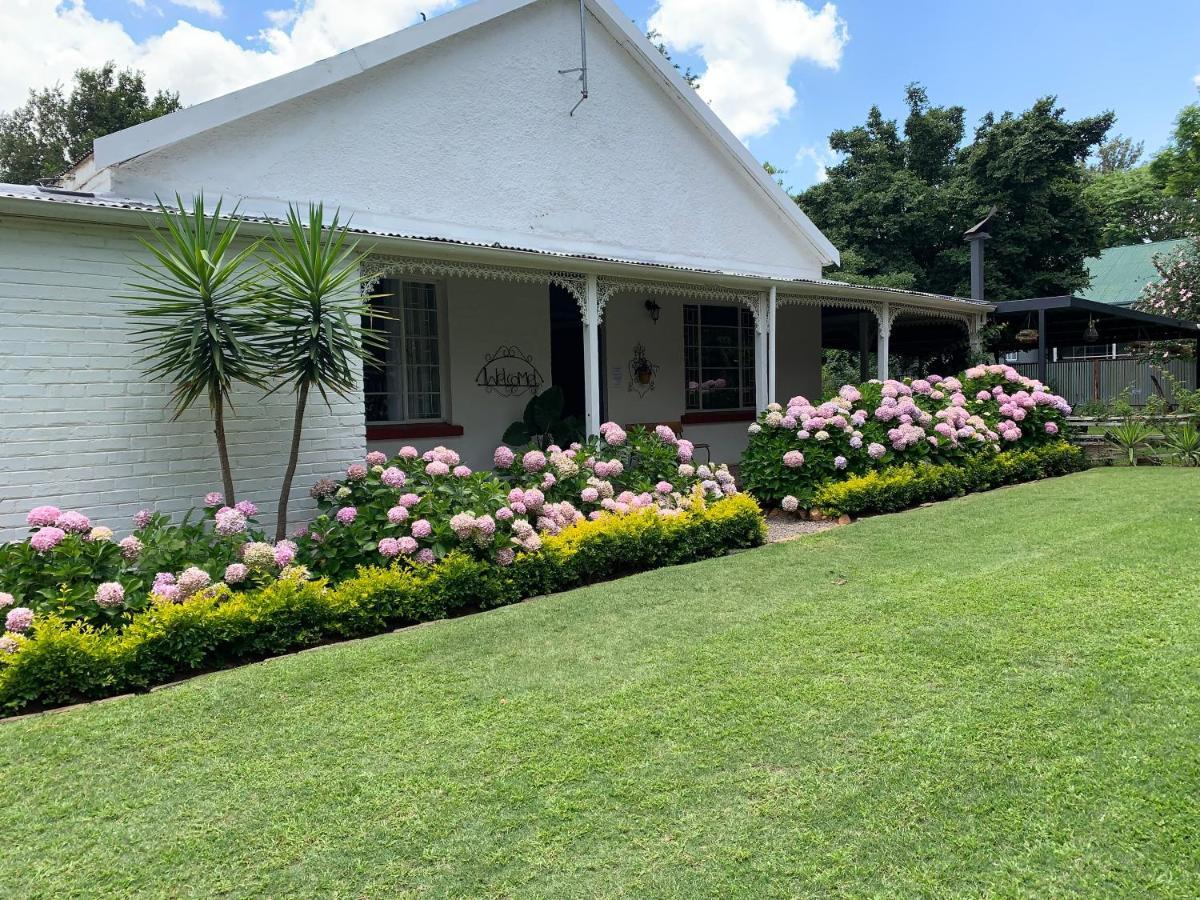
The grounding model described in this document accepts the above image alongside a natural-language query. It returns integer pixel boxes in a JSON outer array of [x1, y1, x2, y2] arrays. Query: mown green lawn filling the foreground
[[0, 469, 1200, 898]]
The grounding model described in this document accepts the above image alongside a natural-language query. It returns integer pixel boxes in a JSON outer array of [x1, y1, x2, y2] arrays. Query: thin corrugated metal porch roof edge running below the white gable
[[0, 184, 991, 308]]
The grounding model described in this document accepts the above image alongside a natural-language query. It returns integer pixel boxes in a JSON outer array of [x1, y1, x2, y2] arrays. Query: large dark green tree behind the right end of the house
[[797, 85, 1112, 300]]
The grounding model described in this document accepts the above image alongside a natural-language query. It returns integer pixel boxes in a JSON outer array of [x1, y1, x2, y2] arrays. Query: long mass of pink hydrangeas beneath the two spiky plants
[[0, 422, 737, 653]]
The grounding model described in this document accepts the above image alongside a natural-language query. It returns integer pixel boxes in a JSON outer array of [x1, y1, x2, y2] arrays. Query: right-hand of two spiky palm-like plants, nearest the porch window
[[264, 204, 383, 540]]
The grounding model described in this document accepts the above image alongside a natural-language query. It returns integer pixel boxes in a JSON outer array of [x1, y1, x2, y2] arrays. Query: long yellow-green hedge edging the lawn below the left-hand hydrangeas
[[0, 494, 766, 714]]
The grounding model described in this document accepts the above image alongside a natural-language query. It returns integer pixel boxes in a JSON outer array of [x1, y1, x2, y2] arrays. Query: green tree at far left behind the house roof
[[0, 62, 180, 184]]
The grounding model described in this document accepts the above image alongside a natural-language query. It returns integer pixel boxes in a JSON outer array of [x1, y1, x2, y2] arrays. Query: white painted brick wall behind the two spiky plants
[[0, 216, 366, 540]]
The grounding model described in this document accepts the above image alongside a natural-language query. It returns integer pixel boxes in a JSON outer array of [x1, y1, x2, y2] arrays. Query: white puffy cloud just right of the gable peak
[[649, 0, 850, 140]]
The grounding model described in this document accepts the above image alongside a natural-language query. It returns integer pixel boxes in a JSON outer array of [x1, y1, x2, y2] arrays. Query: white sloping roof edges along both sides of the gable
[[95, 0, 840, 265]]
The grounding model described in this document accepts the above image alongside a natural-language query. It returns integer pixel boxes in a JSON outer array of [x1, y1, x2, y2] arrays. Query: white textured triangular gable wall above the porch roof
[[105, 0, 821, 277]]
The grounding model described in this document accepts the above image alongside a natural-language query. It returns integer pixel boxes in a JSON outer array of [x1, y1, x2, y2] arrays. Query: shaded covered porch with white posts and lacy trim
[[362, 247, 991, 466]]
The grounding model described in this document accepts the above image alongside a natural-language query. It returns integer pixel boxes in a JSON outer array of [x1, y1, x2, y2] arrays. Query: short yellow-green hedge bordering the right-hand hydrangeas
[[812, 440, 1086, 516]]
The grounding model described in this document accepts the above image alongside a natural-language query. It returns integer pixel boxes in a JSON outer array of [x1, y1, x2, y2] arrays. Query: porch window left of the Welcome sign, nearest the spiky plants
[[362, 280, 445, 422]]
